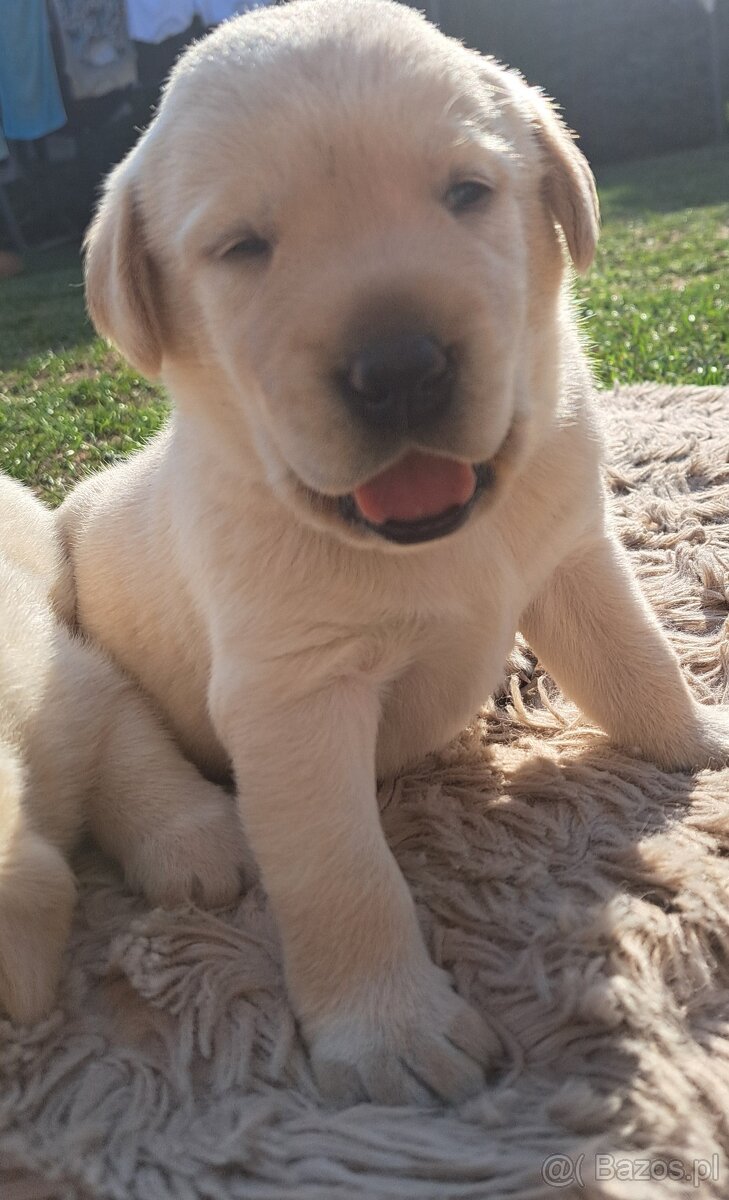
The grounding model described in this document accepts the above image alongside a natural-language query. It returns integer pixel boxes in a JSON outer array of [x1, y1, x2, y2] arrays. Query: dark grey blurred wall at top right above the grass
[[416, 0, 729, 164]]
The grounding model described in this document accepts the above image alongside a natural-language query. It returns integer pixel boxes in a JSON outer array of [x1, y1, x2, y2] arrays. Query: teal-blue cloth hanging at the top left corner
[[0, 0, 66, 142]]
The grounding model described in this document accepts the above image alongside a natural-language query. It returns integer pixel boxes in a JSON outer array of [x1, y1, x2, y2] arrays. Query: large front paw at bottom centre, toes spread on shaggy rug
[[305, 965, 500, 1104]]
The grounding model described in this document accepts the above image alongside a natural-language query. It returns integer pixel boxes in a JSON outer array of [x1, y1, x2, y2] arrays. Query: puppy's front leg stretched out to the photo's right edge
[[520, 532, 729, 769]]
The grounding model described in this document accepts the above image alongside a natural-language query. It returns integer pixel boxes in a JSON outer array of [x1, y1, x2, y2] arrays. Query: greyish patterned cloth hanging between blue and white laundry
[[50, 0, 137, 100]]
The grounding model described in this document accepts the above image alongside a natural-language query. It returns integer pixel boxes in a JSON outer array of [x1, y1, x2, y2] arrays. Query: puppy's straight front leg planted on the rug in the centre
[[211, 677, 495, 1103]]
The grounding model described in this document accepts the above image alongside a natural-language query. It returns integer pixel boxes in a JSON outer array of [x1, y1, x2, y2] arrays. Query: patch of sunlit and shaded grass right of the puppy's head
[[578, 145, 729, 384]]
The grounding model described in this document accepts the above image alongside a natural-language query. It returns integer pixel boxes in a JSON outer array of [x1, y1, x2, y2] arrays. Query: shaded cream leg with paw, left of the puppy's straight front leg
[[89, 659, 252, 907]]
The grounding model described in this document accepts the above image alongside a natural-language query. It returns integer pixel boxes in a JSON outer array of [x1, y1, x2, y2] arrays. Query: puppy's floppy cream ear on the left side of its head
[[84, 160, 163, 379]]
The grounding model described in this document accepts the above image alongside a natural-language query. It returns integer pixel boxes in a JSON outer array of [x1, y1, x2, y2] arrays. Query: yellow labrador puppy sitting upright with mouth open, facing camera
[[60, 0, 729, 1102]]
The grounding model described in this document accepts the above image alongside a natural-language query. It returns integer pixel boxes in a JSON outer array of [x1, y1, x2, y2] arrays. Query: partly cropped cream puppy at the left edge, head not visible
[[0, 476, 245, 1024]]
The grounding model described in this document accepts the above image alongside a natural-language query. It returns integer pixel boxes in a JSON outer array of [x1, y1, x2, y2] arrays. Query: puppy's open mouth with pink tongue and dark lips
[[338, 451, 494, 546]]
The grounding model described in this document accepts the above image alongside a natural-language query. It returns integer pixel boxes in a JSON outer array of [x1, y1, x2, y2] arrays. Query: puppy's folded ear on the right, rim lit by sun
[[526, 88, 600, 271]]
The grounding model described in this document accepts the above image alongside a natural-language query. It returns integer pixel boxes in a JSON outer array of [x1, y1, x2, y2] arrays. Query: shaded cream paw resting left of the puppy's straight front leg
[[123, 785, 255, 908]]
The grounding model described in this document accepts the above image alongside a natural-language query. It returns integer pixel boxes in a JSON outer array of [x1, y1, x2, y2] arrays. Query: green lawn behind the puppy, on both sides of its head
[[0, 146, 729, 502]]
